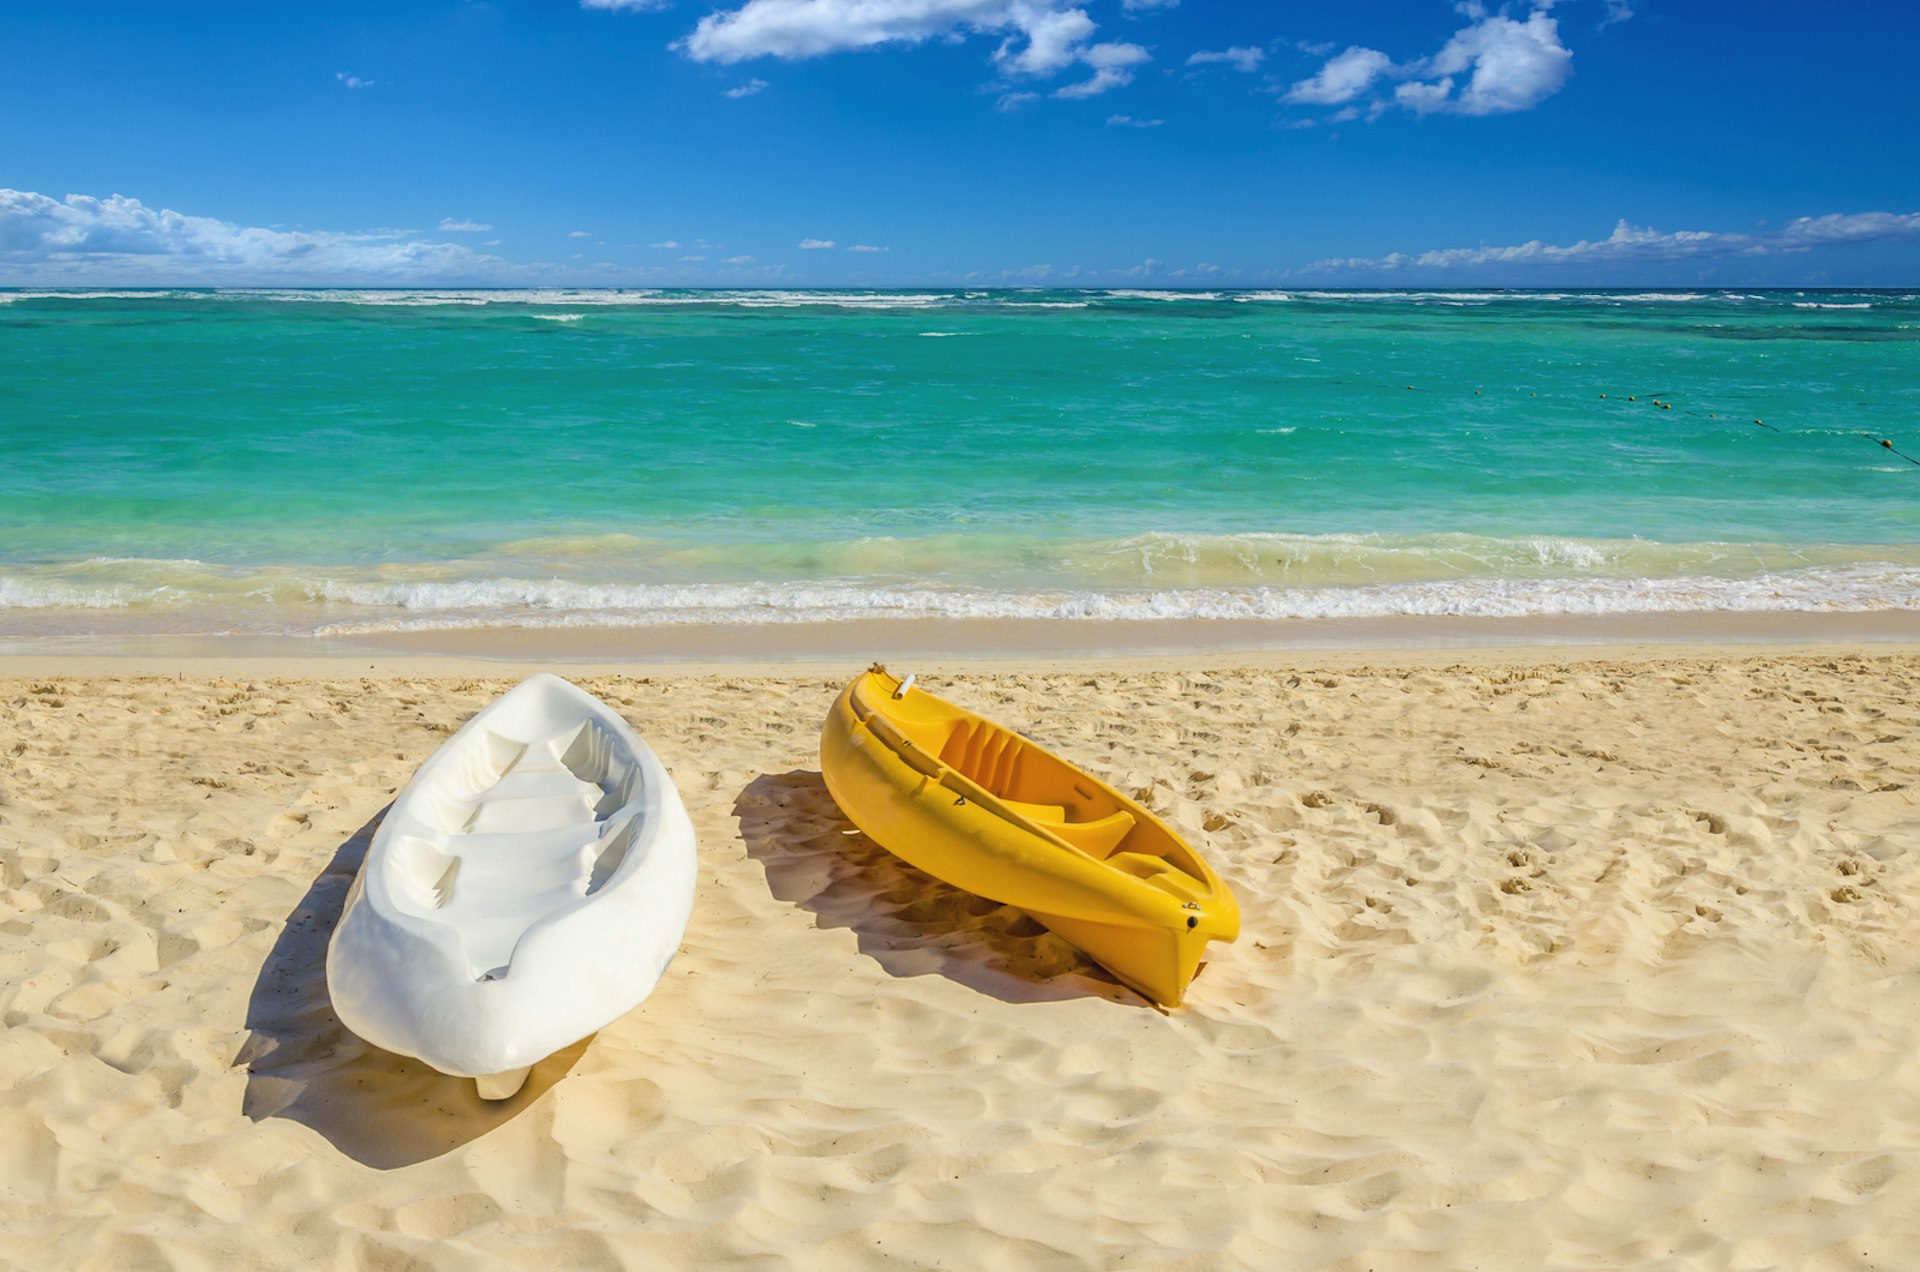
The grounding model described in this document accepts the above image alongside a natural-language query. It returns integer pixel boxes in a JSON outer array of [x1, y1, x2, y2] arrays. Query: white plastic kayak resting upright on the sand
[[326, 674, 695, 1099]]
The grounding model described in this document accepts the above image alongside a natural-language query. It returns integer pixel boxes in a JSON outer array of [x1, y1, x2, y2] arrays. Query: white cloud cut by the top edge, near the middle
[[676, 0, 1150, 100]]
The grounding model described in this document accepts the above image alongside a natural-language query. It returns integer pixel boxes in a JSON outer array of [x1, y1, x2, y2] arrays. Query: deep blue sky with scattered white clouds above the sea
[[0, 0, 1920, 286]]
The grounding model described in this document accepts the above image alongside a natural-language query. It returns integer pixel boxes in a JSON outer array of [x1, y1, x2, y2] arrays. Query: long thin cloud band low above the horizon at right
[[1298, 211, 1920, 273]]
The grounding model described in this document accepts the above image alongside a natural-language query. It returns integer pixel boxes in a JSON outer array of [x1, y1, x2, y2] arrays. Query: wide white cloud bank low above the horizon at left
[[0, 188, 516, 286]]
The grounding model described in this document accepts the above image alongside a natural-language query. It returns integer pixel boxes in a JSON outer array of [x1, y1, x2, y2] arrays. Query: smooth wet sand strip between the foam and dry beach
[[0, 611, 1920, 676]]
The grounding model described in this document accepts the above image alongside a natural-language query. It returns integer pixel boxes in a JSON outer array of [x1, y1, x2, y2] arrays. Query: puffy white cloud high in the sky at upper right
[[1286, 0, 1574, 117]]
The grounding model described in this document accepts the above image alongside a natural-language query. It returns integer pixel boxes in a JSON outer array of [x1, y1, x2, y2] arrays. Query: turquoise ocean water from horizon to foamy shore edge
[[0, 290, 1920, 638]]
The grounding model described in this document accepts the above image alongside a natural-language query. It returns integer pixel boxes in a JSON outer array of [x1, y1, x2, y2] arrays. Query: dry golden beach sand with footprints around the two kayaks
[[0, 646, 1920, 1272]]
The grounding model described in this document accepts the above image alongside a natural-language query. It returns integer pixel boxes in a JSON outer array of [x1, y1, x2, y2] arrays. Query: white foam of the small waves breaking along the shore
[[0, 557, 1920, 636]]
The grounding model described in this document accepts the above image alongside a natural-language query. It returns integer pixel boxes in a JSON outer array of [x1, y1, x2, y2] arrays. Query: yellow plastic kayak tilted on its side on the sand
[[820, 667, 1240, 1007]]
